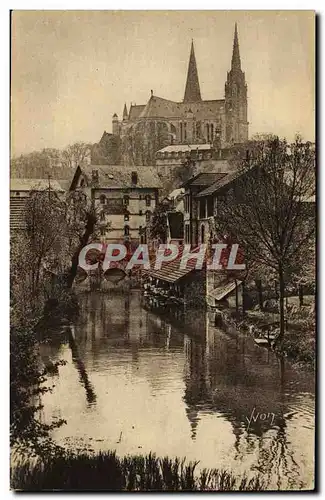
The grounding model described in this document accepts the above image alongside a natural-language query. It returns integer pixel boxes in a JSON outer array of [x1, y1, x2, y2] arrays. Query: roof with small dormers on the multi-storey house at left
[[70, 165, 161, 189]]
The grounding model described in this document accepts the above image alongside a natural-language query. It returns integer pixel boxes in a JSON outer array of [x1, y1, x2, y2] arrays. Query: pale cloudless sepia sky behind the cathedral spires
[[11, 10, 315, 156]]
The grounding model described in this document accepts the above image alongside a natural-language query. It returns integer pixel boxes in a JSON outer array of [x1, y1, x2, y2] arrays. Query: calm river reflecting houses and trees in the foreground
[[41, 291, 315, 489]]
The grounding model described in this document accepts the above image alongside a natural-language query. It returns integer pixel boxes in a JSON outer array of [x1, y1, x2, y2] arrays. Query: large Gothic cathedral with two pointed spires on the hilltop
[[94, 24, 248, 165]]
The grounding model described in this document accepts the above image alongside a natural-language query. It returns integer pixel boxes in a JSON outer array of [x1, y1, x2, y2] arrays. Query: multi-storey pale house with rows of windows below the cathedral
[[70, 165, 161, 245]]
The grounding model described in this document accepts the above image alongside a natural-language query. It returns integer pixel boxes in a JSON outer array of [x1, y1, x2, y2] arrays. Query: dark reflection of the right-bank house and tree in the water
[[180, 318, 312, 485]]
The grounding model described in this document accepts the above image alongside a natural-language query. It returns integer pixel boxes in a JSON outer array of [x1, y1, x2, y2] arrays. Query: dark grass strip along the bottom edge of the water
[[11, 452, 265, 491]]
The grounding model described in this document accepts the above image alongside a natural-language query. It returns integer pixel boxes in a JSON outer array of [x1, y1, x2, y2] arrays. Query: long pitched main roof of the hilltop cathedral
[[139, 95, 224, 120]]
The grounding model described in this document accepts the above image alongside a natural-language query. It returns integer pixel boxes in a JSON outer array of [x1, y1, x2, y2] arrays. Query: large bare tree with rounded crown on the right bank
[[215, 137, 315, 341]]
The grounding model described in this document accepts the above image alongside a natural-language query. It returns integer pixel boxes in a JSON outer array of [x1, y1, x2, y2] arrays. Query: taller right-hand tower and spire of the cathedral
[[225, 23, 248, 144]]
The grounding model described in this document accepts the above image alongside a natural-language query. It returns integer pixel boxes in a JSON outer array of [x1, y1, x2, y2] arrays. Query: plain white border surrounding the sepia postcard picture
[[0, 0, 325, 498]]
